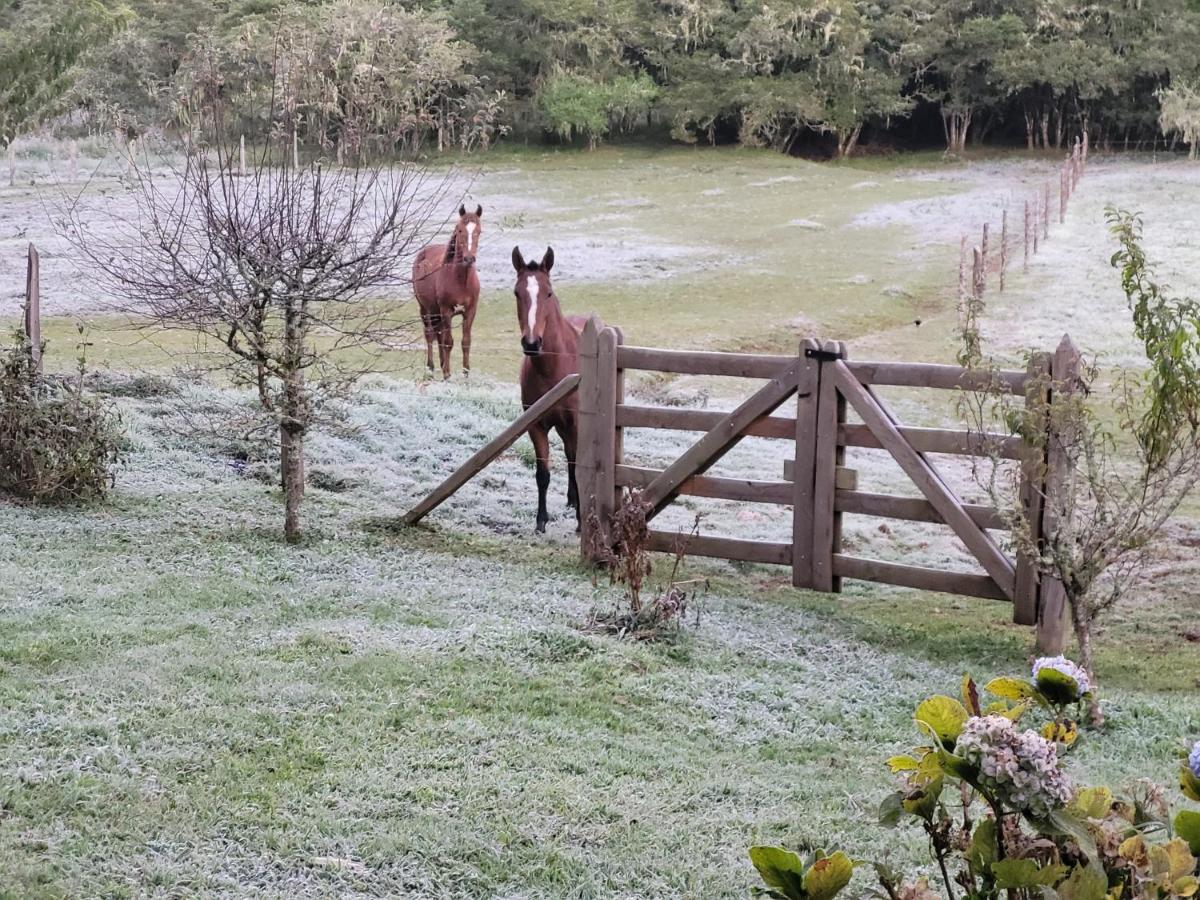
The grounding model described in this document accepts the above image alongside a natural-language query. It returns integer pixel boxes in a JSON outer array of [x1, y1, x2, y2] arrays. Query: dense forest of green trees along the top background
[[7, 0, 1200, 156]]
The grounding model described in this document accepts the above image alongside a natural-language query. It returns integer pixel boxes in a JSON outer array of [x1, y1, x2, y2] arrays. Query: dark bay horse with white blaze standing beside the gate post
[[512, 247, 587, 532]]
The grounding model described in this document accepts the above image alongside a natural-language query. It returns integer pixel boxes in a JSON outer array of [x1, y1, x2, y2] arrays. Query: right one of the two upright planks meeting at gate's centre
[[812, 341, 845, 590]]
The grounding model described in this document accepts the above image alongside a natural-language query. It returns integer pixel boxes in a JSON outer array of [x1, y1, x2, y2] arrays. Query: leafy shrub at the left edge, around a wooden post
[[0, 341, 120, 503]]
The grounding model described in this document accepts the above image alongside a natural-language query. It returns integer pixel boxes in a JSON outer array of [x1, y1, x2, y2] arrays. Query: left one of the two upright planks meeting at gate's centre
[[784, 338, 821, 588]]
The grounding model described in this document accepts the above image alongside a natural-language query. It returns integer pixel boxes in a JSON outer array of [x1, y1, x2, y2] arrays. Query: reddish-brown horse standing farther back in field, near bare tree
[[413, 206, 484, 378]]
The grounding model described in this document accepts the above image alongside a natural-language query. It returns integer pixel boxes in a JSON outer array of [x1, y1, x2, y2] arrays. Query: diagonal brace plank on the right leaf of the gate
[[829, 360, 1015, 599]]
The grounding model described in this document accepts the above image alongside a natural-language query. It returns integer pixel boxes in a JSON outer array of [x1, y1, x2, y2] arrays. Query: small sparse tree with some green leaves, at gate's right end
[[960, 209, 1200, 691]]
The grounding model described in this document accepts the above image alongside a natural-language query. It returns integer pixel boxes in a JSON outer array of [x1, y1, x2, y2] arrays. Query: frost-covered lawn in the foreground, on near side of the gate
[[0, 379, 1200, 898]]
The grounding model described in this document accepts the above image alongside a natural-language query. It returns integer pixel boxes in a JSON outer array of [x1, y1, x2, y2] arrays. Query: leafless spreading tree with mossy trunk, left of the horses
[[64, 140, 451, 540]]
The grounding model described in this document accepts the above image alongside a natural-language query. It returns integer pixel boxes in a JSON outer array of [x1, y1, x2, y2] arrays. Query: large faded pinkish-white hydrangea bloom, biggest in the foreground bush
[[955, 715, 1074, 818]]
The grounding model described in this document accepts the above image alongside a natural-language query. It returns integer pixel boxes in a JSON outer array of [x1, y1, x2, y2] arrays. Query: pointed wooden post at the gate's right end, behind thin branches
[[1037, 335, 1084, 655]]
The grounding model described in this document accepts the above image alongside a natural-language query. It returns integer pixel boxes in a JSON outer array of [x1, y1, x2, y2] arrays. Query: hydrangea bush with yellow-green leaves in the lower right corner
[[750, 658, 1200, 900]]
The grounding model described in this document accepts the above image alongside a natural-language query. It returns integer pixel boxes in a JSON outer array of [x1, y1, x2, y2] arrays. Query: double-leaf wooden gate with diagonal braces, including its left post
[[576, 319, 1078, 652]]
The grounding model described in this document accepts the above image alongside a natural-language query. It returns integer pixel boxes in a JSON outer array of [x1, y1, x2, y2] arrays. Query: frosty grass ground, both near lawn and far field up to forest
[[0, 148, 1200, 898]]
